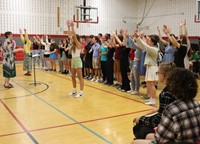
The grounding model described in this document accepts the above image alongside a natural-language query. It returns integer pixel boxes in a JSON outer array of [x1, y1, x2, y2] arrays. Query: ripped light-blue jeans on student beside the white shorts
[[131, 61, 140, 91]]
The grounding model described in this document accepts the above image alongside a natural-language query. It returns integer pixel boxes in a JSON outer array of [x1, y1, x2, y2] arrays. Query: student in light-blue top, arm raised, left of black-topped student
[[157, 27, 175, 62]]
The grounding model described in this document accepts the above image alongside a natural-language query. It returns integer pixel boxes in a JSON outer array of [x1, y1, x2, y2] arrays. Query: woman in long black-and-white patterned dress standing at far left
[[3, 31, 24, 88]]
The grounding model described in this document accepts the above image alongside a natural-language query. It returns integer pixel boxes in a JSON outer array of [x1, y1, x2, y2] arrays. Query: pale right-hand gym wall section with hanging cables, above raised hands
[[136, 0, 200, 36]]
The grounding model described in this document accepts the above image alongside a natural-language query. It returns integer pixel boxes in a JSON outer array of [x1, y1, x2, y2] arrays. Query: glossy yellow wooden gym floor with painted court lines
[[0, 64, 200, 144]]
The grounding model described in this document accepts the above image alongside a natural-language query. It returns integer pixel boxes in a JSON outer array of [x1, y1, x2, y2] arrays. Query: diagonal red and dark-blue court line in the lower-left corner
[[0, 100, 39, 144]]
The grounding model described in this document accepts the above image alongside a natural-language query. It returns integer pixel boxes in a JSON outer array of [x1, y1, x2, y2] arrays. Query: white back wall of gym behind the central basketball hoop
[[0, 0, 136, 35]]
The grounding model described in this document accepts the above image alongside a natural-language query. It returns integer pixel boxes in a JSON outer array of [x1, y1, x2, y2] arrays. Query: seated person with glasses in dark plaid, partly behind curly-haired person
[[133, 62, 175, 139]]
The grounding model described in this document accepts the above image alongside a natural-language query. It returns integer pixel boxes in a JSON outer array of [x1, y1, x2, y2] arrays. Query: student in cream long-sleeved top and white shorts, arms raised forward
[[135, 32, 159, 105]]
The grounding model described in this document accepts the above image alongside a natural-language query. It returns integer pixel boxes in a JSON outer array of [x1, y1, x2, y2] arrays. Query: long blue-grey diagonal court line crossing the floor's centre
[[12, 80, 112, 144]]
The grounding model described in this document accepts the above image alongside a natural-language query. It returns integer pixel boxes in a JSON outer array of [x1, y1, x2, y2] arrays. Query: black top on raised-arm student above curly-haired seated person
[[174, 45, 187, 68]]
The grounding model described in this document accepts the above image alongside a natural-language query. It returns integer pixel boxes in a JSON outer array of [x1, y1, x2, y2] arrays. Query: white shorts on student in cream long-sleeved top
[[145, 66, 158, 81]]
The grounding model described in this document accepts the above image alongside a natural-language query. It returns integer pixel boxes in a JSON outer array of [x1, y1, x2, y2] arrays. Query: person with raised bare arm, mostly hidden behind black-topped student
[[179, 19, 191, 69]]
